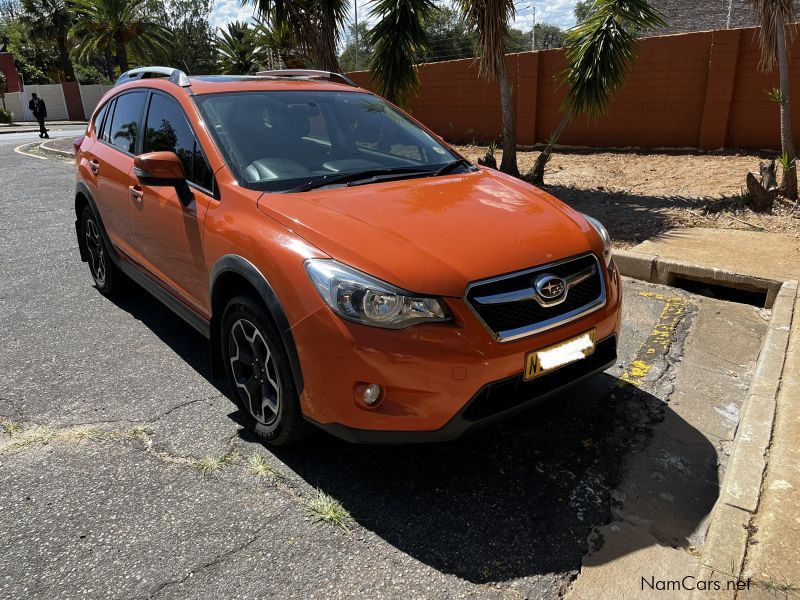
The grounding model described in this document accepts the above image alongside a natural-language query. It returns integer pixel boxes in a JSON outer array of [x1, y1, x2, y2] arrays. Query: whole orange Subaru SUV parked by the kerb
[[75, 67, 620, 445]]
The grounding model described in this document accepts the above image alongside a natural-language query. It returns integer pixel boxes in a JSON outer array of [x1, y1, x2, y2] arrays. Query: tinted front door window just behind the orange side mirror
[[143, 94, 211, 190]]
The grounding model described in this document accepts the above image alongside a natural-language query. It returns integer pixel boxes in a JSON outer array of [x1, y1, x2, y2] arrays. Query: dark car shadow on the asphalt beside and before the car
[[104, 291, 719, 583]]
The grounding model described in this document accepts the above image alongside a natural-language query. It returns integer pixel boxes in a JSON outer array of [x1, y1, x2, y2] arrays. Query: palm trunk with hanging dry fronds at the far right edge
[[748, 0, 797, 200]]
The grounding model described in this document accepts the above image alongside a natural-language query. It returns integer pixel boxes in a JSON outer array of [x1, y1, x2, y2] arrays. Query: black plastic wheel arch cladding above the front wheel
[[209, 254, 303, 394]]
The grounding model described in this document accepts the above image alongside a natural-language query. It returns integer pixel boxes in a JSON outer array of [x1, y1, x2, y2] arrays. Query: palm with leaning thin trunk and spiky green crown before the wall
[[527, 0, 664, 184]]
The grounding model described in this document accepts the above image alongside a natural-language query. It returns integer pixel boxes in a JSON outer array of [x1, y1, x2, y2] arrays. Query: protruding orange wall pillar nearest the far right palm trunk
[[697, 29, 742, 150]]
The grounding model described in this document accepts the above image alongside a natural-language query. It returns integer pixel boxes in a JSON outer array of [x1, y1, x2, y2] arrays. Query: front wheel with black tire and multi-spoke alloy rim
[[219, 296, 309, 446]]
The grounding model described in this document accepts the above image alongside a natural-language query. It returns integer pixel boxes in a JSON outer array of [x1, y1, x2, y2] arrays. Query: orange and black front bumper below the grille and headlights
[[291, 263, 621, 443]]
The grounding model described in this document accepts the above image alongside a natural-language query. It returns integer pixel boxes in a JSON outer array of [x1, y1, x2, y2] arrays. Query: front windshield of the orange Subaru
[[195, 91, 459, 192]]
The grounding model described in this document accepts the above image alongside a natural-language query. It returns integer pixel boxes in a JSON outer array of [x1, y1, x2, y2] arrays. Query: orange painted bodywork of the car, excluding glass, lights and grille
[[76, 79, 621, 440]]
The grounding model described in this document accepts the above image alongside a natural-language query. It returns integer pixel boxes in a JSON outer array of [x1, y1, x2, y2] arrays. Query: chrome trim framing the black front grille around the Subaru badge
[[463, 252, 607, 342]]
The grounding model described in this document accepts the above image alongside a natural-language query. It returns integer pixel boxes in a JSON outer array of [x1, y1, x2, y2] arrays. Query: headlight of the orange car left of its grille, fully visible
[[306, 258, 450, 329]]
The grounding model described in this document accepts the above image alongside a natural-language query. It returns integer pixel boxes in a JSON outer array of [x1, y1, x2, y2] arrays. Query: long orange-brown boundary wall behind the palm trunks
[[350, 29, 800, 149]]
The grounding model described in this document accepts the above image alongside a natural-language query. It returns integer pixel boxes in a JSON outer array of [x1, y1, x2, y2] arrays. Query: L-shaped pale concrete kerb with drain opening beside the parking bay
[[614, 251, 798, 598]]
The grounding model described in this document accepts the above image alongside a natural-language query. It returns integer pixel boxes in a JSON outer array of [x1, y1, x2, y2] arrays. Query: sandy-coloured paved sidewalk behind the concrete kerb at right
[[633, 229, 800, 599]]
